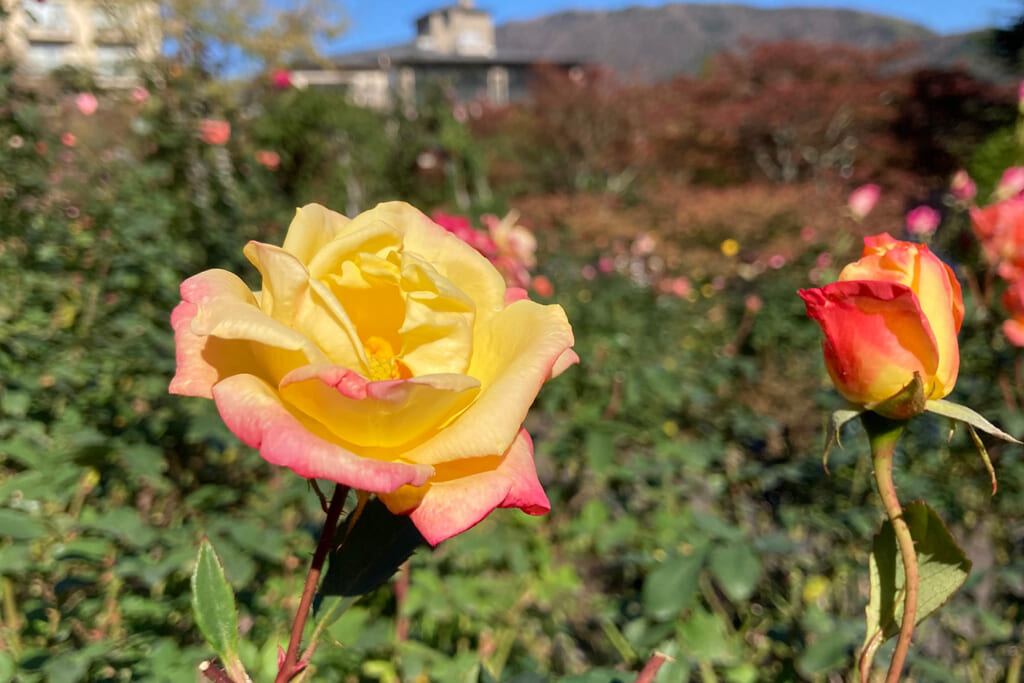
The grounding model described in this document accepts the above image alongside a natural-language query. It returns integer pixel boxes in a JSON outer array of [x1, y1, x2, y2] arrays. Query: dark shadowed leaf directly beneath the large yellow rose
[[319, 498, 426, 597]]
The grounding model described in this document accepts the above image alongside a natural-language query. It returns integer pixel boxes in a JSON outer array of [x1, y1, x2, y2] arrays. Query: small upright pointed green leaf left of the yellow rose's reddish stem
[[191, 537, 239, 659]]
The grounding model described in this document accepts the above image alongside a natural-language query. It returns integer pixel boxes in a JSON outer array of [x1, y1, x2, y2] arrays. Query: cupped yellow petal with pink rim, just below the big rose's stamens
[[281, 366, 480, 450]]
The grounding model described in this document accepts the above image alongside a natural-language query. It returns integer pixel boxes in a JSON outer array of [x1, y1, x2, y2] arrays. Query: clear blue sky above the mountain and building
[[330, 0, 1024, 53]]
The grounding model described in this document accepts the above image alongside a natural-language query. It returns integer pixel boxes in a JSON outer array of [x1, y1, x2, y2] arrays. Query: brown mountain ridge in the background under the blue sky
[[496, 2, 1013, 82]]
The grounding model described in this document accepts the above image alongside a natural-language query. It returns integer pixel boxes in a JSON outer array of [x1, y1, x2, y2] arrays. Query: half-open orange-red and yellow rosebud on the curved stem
[[800, 234, 964, 418]]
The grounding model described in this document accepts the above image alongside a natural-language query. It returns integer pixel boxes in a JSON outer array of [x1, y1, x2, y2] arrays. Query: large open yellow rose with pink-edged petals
[[170, 202, 579, 544]]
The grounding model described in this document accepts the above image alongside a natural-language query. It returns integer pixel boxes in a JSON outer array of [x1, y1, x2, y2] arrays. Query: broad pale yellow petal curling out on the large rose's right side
[[408, 301, 573, 465]]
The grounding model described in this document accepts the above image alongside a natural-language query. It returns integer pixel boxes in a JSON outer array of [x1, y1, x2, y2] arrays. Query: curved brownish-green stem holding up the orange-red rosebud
[[864, 413, 919, 683]]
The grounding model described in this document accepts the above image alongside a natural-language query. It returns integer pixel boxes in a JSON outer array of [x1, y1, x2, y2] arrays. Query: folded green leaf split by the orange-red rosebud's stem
[[862, 501, 971, 660]]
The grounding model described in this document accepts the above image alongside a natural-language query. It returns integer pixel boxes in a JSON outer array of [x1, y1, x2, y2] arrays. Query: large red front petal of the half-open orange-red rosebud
[[800, 281, 939, 405]]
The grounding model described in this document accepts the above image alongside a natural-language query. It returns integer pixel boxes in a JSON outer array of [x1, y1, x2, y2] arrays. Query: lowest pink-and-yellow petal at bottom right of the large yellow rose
[[380, 429, 551, 546]]
